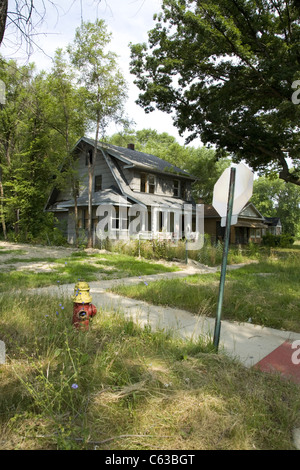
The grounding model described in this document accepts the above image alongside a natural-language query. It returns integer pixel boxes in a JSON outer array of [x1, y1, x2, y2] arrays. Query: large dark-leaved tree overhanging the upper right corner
[[131, 0, 300, 185]]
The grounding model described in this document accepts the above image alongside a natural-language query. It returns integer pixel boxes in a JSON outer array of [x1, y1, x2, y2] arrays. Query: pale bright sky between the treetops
[[0, 0, 201, 146]]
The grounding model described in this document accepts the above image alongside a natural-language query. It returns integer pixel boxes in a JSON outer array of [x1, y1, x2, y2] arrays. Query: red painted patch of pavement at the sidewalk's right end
[[253, 341, 300, 384]]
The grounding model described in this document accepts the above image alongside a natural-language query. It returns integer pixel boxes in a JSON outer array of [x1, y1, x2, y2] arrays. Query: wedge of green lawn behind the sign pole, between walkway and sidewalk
[[113, 253, 300, 332]]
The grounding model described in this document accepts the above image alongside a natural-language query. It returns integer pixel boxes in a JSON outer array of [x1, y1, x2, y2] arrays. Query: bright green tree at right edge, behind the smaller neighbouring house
[[251, 176, 300, 235]]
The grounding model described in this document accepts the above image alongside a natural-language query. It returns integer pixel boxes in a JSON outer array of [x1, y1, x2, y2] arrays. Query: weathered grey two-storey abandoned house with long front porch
[[45, 137, 196, 245]]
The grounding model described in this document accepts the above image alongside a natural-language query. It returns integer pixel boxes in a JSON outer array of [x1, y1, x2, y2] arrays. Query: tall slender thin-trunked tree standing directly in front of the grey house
[[68, 20, 126, 247]]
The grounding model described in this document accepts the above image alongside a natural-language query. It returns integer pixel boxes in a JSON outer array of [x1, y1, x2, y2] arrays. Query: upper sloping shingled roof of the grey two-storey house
[[79, 137, 196, 180]]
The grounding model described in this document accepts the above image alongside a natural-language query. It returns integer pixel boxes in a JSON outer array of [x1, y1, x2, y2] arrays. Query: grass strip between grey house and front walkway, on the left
[[0, 252, 178, 291]]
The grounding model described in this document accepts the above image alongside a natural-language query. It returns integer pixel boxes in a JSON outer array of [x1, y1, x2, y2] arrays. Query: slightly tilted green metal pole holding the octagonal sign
[[213, 168, 236, 350]]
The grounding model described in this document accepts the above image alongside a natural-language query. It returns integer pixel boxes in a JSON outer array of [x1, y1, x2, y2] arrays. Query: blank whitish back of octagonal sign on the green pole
[[212, 163, 254, 227]]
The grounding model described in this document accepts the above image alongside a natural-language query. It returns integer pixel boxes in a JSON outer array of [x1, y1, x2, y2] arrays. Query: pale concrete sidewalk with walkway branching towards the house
[[34, 266, 300, 376]]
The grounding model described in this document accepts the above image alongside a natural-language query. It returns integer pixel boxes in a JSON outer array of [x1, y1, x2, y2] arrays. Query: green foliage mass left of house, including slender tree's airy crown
[[0, 20, 126, 242]]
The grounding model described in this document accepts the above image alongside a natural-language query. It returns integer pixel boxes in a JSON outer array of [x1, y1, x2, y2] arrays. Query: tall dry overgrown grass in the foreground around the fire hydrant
[[0, 294, 300, 450]]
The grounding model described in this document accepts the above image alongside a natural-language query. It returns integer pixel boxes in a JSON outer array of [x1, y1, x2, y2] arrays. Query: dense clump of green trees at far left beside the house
[[0, 51, 85, 241]]
